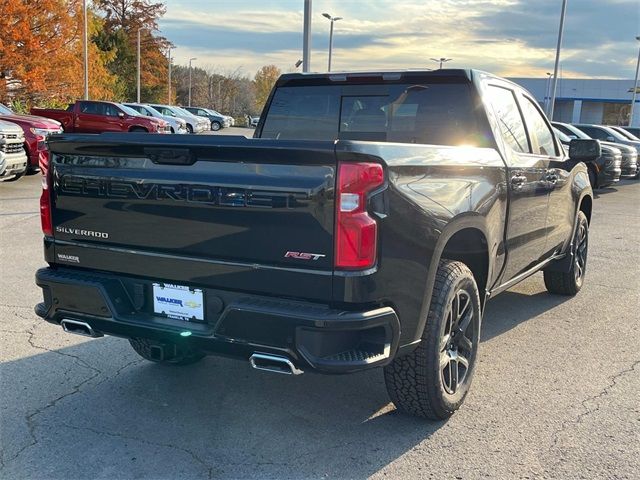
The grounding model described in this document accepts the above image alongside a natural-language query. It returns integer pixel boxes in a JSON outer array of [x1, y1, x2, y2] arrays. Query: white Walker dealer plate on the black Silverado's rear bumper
[[153, 283, 204, 321]]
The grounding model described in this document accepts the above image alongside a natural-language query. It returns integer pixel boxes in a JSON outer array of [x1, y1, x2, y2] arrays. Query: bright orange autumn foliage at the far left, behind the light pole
[[0, 0, 115, 103]]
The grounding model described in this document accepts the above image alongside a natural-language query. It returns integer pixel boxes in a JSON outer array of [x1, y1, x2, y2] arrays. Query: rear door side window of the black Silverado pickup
[[487, 85, 531, 153]]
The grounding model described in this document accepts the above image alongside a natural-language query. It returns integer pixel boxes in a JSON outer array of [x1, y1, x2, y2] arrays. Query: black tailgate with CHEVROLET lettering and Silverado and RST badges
[[48, 134, 336, 300]]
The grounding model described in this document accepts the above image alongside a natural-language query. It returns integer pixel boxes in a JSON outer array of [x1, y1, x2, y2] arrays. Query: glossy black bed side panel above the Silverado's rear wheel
[[334, 142, 507, 345]]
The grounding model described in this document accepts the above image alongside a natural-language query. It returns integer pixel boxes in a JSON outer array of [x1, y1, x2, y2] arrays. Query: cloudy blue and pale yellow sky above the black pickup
[[160, 0, 640, 78]]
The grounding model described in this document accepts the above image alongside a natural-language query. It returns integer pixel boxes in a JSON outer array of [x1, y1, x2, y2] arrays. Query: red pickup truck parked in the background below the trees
[[31, 100, 171, 133]]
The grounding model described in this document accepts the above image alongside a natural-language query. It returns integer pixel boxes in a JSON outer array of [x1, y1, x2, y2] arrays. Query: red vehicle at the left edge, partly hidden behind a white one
[[0, 104, 62, 175]]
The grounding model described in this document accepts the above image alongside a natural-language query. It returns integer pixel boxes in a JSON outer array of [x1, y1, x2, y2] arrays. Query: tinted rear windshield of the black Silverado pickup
[[261, 83, 484, 146]]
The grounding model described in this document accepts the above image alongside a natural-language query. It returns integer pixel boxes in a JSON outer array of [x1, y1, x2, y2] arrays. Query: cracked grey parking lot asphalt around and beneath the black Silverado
[[0, 141, 640, 479]]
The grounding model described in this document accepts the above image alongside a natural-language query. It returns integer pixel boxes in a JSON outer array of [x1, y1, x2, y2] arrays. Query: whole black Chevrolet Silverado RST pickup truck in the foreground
[[36, 70, 600, 418]]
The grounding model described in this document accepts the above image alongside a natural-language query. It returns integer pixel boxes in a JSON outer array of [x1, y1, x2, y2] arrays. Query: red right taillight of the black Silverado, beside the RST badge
[[335, 163, 384, 269]]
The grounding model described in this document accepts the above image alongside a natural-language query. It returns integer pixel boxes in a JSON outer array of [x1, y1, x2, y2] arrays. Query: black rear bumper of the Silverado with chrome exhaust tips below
[[35, 268, 400, 373]]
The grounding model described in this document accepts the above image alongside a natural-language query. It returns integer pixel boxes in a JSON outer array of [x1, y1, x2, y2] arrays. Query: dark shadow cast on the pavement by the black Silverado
[[0, 280, 566, 479]]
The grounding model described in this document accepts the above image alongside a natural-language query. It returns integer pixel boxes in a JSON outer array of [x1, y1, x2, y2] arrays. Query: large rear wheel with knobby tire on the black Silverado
[[384, 260, 481, 420]]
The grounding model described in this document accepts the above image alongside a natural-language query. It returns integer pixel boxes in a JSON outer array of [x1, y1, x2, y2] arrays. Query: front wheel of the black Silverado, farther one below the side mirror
[[544, 212, 589, 295]]
